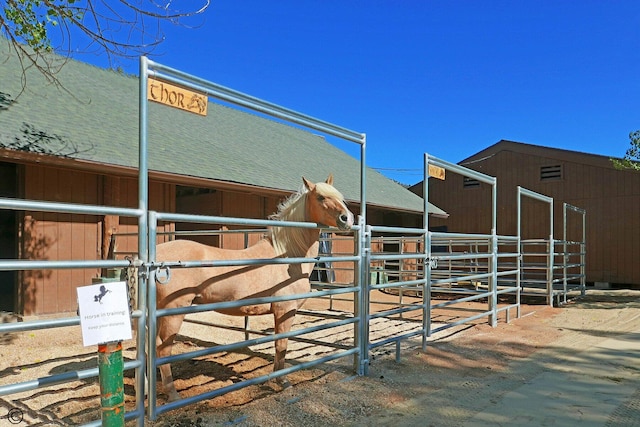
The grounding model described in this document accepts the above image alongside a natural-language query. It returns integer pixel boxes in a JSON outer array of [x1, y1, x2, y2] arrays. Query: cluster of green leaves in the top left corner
[[0, 0, 82, 52]]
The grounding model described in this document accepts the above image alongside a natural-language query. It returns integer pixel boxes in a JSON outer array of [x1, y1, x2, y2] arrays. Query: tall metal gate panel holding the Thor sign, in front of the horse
[[140, 58, 366, 420]]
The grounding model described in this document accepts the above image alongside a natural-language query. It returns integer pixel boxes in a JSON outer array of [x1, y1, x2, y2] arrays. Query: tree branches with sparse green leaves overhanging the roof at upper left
[[0, 0, 211, 89]]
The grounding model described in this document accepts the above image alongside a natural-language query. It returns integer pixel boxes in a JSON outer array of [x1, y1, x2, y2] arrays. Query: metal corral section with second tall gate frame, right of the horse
[[352, 154, 520, 358]]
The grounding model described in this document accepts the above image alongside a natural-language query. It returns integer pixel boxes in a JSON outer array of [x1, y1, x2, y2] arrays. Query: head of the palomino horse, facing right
[[302, 175, 353, 230]]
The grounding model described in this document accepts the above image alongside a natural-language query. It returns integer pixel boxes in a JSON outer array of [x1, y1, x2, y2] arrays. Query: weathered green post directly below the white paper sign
[[98, 342, 125, 427]]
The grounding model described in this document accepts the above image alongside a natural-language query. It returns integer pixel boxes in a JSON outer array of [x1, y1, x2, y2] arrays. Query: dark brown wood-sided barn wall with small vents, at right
[[429, 150, 640, 286]]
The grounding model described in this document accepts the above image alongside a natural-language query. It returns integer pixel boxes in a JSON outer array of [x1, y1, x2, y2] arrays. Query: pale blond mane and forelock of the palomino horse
[[269, 182, 342, 256]]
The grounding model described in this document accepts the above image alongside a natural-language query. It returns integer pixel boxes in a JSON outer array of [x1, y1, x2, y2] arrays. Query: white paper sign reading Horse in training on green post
[[77, 282, 131, 347]]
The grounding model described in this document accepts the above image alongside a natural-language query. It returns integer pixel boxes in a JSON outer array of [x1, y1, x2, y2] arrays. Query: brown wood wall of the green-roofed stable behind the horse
[[16, 163, 404, 316]]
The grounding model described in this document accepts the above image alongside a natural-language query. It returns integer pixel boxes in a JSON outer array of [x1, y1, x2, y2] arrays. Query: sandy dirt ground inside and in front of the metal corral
[[0, 289, 640, 427]]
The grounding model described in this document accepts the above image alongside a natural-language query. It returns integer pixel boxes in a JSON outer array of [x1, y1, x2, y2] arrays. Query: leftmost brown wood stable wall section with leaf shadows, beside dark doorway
[[20, 166, 100, 315]]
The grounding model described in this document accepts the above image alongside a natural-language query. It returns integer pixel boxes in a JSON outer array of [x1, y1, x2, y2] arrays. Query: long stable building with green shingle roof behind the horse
[[0, 43, 446, 315]]
